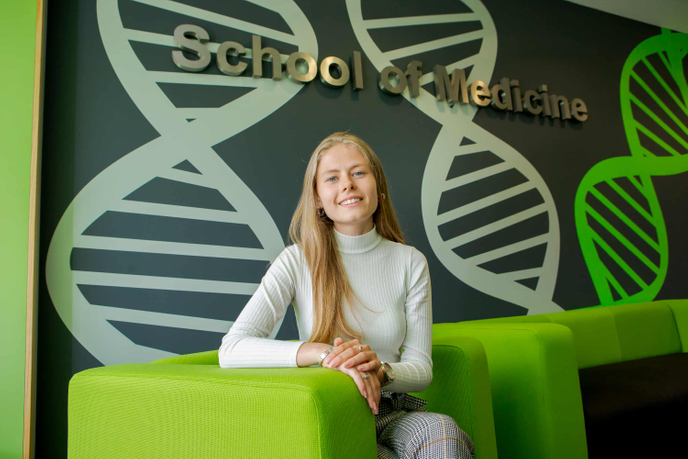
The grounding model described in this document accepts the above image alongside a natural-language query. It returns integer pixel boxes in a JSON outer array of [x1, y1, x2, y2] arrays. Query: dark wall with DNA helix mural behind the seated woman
[[36, 0, 688, 458]]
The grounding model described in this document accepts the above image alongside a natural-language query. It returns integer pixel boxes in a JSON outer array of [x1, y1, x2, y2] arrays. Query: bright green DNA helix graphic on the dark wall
[[575, 29, 688, 305]]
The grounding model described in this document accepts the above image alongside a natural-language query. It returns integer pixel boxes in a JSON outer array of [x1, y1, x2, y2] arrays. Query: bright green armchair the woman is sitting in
[[68, 337, 497, 459]]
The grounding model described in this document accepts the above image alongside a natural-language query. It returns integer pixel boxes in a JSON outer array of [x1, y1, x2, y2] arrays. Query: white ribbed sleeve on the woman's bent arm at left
[[219, 246, 303, 368]]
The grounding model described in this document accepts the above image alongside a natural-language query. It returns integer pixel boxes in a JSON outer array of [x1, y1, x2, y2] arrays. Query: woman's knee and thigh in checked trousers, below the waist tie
[[378, 411, 474, 459]]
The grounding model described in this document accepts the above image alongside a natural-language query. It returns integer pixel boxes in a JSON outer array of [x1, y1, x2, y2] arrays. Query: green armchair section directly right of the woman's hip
[[414, 336, 497, 459]]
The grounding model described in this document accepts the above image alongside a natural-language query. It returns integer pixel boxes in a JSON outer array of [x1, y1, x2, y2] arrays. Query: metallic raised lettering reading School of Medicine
[[172, 24, 588, 122]]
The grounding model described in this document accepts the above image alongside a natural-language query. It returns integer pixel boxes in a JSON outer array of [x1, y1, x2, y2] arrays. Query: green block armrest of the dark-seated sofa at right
[[434, 322, 587, 459]]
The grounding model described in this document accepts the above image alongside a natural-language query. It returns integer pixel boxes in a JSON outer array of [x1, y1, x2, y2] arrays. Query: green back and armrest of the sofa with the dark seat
[[433, 300, 688, 459]]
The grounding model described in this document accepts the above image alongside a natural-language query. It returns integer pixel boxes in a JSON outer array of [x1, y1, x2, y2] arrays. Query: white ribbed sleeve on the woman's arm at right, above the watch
[[384, 248, 432, 392]]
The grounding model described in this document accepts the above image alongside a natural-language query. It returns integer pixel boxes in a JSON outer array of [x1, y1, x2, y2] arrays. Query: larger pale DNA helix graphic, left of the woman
[[46, 0, 318, 365]]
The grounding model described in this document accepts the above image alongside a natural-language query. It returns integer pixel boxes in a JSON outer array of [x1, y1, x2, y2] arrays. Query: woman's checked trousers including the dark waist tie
[[375, 391, 475, 459]]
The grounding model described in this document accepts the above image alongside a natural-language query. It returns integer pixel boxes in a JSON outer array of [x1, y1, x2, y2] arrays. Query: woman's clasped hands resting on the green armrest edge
[[322, 338, 382, 414]]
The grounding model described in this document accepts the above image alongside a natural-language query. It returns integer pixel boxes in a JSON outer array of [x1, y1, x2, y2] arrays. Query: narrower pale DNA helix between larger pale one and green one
[[347, 0, 562, 314]]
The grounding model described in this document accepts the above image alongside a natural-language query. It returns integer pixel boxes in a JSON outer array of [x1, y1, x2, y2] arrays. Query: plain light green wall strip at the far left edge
[[0, 0, 36, 459]]
